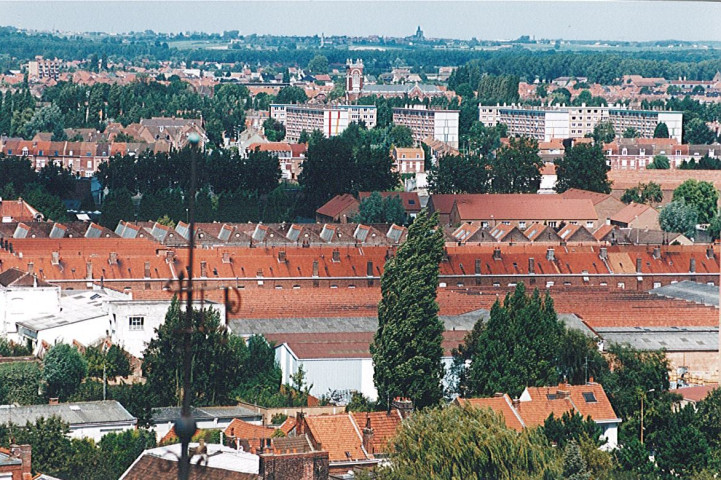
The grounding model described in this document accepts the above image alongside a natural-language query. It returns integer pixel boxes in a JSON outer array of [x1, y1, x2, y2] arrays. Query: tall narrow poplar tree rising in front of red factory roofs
[[370, 211, 443, 408]]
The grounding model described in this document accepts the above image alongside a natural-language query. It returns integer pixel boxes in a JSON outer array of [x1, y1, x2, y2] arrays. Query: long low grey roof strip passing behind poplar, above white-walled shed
[[230, 309, 595, 336]]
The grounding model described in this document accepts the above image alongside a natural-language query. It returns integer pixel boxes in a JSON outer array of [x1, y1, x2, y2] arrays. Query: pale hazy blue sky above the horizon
[[0, 0, 721, 41]]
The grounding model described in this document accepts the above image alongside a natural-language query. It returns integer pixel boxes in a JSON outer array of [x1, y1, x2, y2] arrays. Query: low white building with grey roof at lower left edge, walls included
[[0, 400, 138, 442]]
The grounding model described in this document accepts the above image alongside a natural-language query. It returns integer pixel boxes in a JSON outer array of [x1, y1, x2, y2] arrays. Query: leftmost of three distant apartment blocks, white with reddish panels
[[270, 104, 377, 143]]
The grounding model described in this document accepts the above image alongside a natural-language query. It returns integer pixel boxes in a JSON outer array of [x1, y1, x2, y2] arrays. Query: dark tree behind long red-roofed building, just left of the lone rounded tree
[[491, 137, 543, 193]]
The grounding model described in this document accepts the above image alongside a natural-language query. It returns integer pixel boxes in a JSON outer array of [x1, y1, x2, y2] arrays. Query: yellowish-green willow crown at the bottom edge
[[377, 406, 561, 480]]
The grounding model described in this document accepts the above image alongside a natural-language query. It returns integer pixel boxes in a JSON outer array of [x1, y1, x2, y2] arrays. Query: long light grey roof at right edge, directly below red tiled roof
[[596, 327, 719, 352]]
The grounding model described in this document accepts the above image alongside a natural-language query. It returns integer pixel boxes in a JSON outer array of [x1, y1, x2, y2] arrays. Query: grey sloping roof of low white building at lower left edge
[[0, 400, 137, 427]]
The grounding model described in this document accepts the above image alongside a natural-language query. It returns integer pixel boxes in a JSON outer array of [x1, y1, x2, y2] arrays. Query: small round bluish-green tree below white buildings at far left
[[43, 343, 88, 400]]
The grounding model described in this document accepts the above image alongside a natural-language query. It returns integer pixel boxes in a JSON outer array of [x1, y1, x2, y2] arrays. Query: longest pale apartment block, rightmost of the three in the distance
[[478, 104, 683, 142]]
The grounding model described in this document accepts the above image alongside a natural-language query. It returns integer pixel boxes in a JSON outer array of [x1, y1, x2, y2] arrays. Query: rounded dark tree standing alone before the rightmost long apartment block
[[556, 143, 611, 193]]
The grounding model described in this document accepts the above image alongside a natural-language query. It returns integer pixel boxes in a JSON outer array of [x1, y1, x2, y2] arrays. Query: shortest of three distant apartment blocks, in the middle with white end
[[393, 105, 460, 148]]
